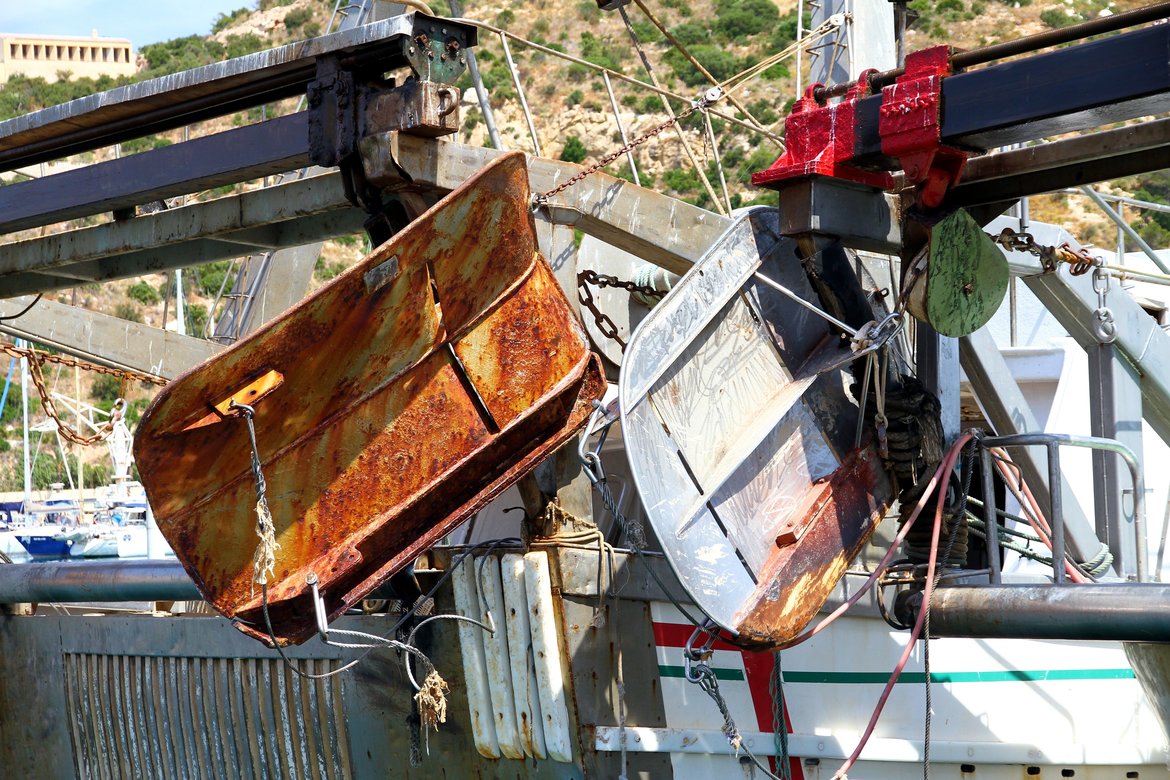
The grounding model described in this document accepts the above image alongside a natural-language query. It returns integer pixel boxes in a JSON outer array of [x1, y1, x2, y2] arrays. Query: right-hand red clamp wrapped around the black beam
[[878, 46, 968, 208]]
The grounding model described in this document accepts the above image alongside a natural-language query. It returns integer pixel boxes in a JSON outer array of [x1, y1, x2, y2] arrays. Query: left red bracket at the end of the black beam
[[751, 70, 893, 189]]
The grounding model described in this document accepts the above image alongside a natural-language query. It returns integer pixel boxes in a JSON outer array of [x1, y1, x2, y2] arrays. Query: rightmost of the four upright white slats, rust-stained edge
[[524, 552, 573, 762]]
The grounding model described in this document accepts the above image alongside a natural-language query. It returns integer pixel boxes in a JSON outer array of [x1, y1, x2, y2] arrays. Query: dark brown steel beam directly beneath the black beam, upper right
[[948, 119, 1170, 206]]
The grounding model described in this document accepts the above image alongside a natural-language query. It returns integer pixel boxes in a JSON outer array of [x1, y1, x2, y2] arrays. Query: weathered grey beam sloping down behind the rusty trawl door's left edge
[[0, 296, 221, 379]]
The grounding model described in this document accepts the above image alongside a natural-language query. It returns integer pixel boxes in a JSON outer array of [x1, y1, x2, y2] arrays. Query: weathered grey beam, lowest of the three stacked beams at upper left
[[0, 173, 365, 296]]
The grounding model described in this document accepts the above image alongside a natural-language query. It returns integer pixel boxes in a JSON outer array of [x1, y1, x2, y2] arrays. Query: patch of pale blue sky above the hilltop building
[[0, 0, 256, 51]]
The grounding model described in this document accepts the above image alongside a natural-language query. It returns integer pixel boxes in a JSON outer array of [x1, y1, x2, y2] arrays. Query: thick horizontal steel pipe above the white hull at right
[[920, 582, 1170, 642]]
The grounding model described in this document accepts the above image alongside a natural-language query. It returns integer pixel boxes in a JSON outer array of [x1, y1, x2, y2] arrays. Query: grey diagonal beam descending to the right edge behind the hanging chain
[[986, 216, 1170, 442]]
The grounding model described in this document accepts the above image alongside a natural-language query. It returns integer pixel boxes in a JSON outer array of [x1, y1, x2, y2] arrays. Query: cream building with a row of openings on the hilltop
[[0, 30, 137, 84]]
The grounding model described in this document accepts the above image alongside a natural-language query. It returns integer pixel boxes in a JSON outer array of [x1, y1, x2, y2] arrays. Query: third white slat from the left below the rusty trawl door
[[497, 553, 546, 759]]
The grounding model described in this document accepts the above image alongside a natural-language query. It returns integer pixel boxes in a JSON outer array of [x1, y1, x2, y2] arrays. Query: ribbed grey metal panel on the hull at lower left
[[64, 653, 352, 780]]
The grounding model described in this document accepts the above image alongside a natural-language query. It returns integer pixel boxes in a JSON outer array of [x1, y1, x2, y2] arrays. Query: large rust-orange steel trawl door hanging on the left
[[135, 154, 605, 642]]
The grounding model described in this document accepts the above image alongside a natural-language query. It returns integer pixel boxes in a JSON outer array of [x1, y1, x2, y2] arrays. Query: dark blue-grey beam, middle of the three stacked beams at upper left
[[0, 112, 309, 233]]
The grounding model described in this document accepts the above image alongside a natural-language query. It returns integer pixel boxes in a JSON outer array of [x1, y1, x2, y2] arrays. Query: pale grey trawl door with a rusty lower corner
[[620, 209, 890, 646]]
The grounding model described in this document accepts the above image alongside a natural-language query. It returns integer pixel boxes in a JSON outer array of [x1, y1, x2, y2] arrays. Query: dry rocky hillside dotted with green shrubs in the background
[[0, 0, 1170, 489]]
